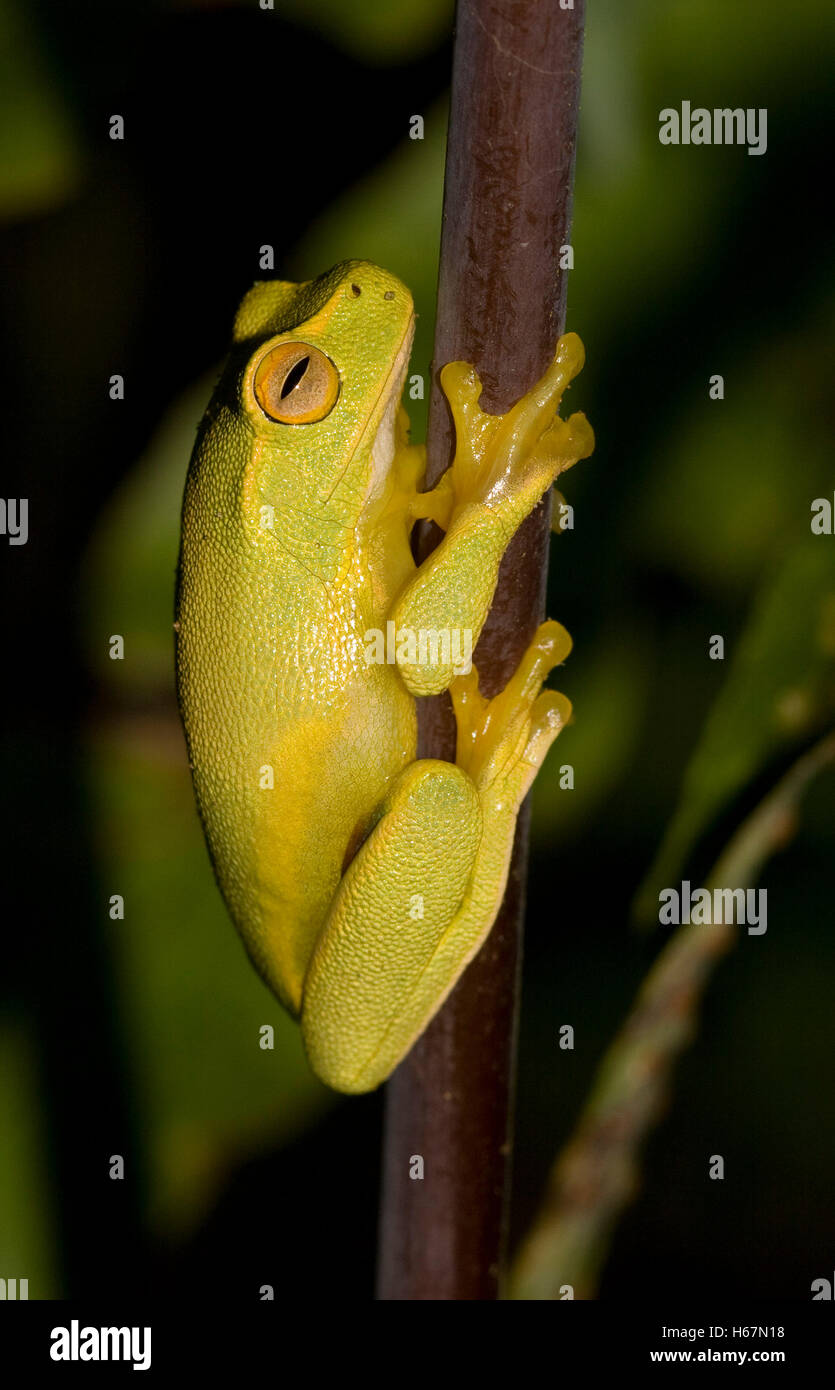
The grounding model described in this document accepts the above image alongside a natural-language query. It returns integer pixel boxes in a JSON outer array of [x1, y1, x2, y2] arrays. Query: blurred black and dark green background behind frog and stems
[[0, 0, 835, 1301]]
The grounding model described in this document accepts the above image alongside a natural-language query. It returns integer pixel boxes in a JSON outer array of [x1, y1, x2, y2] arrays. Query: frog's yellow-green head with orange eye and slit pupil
[[226, 261, 414, 517]]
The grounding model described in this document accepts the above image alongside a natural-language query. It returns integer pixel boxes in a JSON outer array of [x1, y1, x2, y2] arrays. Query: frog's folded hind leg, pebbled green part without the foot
[[301, 759, 482, 1091]]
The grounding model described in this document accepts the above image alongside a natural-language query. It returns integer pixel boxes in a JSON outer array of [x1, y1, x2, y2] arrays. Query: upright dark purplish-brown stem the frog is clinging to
[[378, 0, 584, 1300]]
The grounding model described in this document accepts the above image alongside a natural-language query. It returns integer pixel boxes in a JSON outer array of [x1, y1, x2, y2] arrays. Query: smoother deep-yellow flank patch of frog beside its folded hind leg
[[239, 669, 417, 1012]]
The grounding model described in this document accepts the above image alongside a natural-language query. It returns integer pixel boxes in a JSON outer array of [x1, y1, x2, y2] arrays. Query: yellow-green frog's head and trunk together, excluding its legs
[[176, 263, 417, 1011]]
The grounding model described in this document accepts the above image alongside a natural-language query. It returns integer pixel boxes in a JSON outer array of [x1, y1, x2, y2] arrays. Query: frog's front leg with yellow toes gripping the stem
[[392, 334, 595, 695]]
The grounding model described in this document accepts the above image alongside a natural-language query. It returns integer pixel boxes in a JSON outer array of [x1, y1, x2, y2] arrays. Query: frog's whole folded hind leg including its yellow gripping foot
[[301, 623, 571, 1091]]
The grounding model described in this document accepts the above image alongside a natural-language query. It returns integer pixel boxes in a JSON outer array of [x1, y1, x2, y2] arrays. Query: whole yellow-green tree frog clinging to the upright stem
[[175, 260, 593, 1094]]
